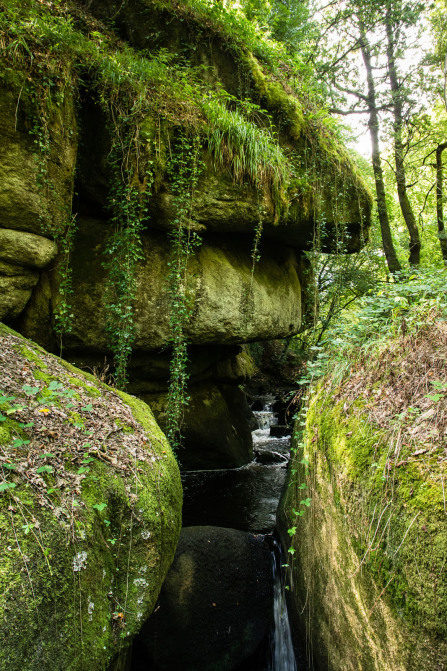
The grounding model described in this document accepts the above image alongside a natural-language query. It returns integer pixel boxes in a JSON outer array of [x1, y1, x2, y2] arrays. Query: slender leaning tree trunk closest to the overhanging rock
[[359, 25, 402, 273]]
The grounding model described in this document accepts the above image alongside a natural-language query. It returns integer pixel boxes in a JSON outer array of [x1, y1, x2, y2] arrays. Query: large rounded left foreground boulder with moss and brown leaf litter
[[0, 325, 182, 671]]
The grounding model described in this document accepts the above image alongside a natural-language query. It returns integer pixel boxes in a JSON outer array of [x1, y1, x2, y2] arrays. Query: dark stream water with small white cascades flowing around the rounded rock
[[128, 397, 300, 671]]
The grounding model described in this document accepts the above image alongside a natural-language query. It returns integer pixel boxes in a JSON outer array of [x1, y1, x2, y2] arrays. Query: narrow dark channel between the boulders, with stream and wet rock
[[130, 396, 305, 671]]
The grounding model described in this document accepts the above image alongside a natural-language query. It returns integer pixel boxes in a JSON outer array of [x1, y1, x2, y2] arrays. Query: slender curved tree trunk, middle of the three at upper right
[[385, 9, 421, 266]]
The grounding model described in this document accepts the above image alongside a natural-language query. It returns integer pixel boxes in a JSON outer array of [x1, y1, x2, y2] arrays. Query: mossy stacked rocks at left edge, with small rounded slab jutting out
[[0, 75, 76, 321]]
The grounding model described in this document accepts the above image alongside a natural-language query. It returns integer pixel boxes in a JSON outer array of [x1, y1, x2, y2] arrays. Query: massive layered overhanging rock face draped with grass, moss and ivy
[[0, 0, 372, 342]]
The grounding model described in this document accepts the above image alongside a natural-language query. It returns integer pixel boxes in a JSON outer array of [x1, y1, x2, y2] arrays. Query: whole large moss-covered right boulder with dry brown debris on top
[[280, 322, 447, 671]]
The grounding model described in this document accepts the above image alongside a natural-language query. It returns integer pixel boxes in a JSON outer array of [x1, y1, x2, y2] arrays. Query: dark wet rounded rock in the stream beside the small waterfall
[[132, 526, 273, 671]]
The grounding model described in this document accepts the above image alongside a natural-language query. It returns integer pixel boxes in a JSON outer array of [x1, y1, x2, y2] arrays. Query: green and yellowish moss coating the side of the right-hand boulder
[[282, 376, 447, 671]]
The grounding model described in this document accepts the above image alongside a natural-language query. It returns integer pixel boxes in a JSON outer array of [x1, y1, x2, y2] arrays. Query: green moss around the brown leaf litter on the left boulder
[[0, 327, 181, 671]]
